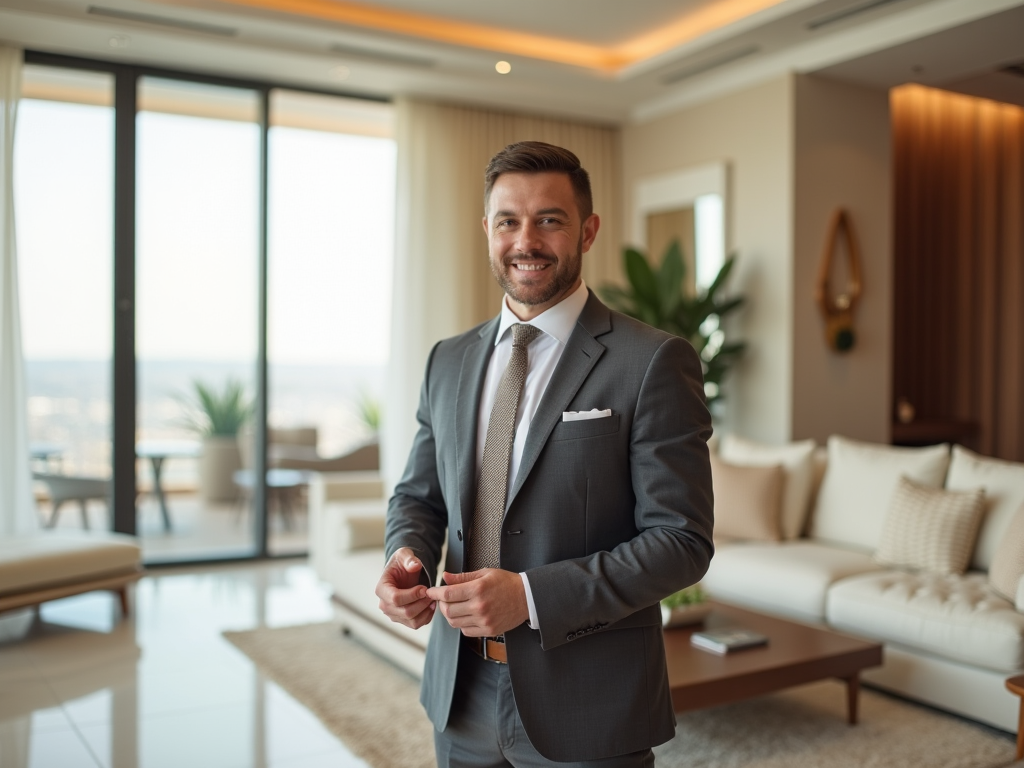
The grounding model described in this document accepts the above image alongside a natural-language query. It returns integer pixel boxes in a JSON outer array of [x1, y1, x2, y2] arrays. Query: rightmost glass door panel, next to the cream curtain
[[267, 90, 395, 554]]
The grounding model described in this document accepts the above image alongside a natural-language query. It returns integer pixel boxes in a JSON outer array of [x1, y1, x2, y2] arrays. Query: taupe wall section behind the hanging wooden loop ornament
[[792, 76, 893, 442]]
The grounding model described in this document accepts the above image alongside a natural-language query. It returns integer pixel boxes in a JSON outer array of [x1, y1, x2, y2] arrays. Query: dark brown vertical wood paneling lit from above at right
[[892, 86, 1024, 461]]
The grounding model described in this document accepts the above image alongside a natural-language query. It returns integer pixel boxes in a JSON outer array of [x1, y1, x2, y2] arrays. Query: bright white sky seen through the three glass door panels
[[14, 91, 395, 365]]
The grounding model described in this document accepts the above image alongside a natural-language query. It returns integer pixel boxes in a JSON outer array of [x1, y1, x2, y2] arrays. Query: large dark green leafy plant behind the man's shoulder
[[600, 241, 746, 404]]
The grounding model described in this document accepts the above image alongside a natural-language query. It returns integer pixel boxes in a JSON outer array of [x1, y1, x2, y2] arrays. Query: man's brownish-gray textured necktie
[[466, 323, 541, 570]]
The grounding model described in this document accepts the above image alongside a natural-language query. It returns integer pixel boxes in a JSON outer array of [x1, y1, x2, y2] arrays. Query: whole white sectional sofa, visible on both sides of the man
[[310, 437, 1024, 731]]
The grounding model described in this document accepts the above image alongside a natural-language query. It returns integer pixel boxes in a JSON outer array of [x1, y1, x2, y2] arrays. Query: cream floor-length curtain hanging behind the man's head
[[381, 99, 621, 486]]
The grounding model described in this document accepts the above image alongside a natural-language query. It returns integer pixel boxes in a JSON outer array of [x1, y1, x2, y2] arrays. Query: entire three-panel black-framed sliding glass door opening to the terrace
[[15, 52, 395, 562]]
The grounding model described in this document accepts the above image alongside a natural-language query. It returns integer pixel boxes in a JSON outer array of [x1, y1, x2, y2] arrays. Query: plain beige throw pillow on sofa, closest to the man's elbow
[[711, 455, 783, 542]]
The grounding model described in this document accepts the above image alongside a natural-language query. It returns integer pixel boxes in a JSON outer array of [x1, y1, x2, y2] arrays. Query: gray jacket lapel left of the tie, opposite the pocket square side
[[455, 317, 499, 536]]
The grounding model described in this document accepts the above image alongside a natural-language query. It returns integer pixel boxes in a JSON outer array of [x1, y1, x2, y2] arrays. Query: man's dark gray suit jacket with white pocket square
[[386, 294, 714, 761]]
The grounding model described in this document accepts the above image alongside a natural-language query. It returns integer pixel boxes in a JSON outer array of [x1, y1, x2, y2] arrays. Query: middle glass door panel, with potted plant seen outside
[[135, 77, 260, 561]]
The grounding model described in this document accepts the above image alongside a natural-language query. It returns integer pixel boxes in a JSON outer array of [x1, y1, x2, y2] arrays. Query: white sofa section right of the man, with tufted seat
[[702, 437, 1024, 731]]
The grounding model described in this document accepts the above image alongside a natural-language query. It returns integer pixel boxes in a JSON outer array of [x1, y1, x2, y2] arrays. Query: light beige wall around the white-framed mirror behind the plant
[[622, 76, 794, 442]]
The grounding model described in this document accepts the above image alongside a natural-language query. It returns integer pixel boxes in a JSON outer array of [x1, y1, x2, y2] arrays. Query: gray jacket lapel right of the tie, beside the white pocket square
[[506, 291, 611, 508]]
